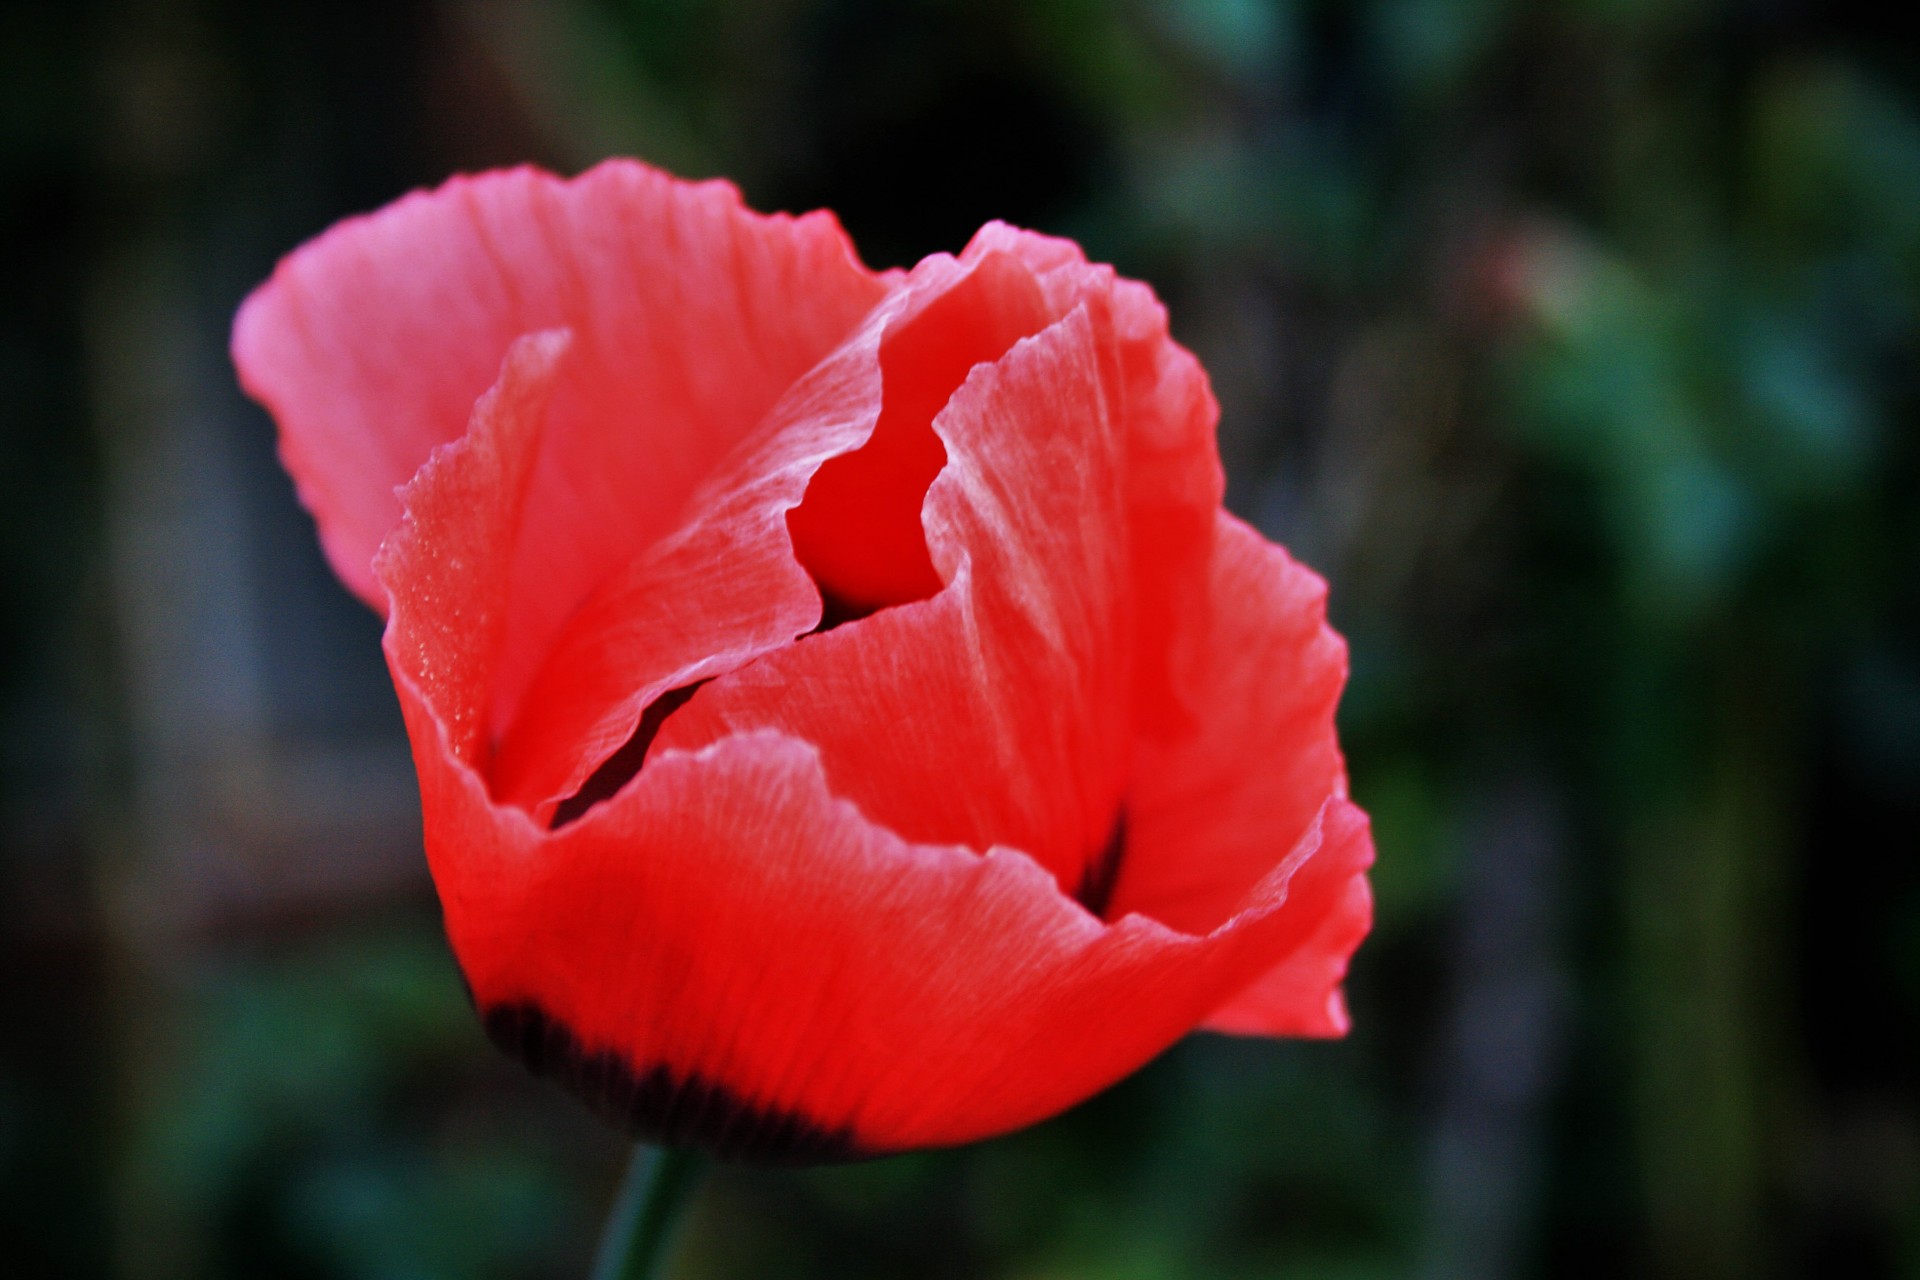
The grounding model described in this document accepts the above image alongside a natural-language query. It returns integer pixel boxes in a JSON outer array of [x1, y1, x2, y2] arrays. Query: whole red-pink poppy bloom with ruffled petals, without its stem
[[234, 161, 1373, 1159]]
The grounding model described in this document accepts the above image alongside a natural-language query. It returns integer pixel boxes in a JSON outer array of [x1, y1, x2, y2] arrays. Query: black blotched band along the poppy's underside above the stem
[[480, 1000, 879, 1165]]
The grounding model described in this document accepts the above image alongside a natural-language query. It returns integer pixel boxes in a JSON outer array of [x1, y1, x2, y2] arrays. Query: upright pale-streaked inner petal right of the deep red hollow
[[660, 307, 1133, 892]]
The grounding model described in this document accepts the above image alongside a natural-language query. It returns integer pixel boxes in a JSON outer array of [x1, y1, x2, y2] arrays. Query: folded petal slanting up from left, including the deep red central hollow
[[493, 245, 1050, 821]]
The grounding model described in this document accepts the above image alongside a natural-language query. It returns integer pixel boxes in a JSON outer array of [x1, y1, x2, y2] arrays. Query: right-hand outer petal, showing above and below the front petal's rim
[[1112, 514, 1371, 1034]]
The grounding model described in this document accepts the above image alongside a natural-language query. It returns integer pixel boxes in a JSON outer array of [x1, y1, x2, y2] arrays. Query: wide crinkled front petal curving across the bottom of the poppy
[[451, 733, 1365, 1159]]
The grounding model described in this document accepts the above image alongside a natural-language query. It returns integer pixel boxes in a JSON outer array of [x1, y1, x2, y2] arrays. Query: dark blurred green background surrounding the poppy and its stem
[[0, 0, 1920, 1280]]
